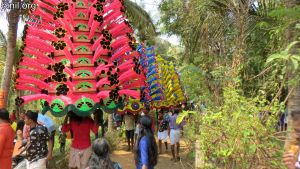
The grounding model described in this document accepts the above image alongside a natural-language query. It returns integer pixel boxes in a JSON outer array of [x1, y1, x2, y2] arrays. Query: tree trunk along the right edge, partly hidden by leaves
[[285, 0, 300, 151]]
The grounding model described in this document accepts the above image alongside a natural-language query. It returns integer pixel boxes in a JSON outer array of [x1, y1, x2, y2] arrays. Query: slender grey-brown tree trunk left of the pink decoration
[[1, 0, 19, 107]]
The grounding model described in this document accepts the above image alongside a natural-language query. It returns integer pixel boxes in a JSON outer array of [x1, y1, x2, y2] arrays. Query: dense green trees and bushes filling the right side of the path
[[160, 0, 300, 169]]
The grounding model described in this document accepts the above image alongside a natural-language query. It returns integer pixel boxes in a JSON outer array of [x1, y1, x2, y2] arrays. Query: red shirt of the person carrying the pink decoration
[[62, 118, 98, 150]]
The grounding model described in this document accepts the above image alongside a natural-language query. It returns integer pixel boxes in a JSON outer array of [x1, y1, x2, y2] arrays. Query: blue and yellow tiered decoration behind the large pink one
[[118, 44, 186, 114]]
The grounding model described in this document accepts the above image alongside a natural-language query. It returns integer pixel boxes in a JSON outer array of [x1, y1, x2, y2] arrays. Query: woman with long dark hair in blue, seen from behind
[[134, 115, 158, 169]]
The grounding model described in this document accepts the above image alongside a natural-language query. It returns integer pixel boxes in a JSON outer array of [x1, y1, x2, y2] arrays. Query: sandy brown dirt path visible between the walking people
[[112, 142, 191, 169]]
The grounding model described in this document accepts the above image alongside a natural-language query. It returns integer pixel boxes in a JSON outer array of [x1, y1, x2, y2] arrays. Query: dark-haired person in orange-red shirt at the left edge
[[0, 109, 15, 169]]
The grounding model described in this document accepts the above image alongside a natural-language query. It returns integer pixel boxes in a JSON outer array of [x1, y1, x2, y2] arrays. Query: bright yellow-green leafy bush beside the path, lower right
[[185, 88, 283, 169]]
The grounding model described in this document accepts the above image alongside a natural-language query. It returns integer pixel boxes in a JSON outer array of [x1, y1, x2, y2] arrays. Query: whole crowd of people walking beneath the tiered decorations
[[0, 108, 183, 169]]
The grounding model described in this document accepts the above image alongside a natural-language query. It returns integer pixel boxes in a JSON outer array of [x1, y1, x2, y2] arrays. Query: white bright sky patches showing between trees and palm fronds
[[0, 0, 180, 45]]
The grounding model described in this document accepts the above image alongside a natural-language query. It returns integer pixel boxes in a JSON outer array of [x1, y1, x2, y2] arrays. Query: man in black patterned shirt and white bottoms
[[24, 111, 52, 169]]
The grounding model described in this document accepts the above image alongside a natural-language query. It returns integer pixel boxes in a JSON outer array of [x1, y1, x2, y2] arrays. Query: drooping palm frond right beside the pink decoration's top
[[124, 0, 157, 39]]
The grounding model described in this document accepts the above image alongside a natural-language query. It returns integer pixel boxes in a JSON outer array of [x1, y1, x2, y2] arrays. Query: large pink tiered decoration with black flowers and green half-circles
[[16, 0, 145, 116]]
